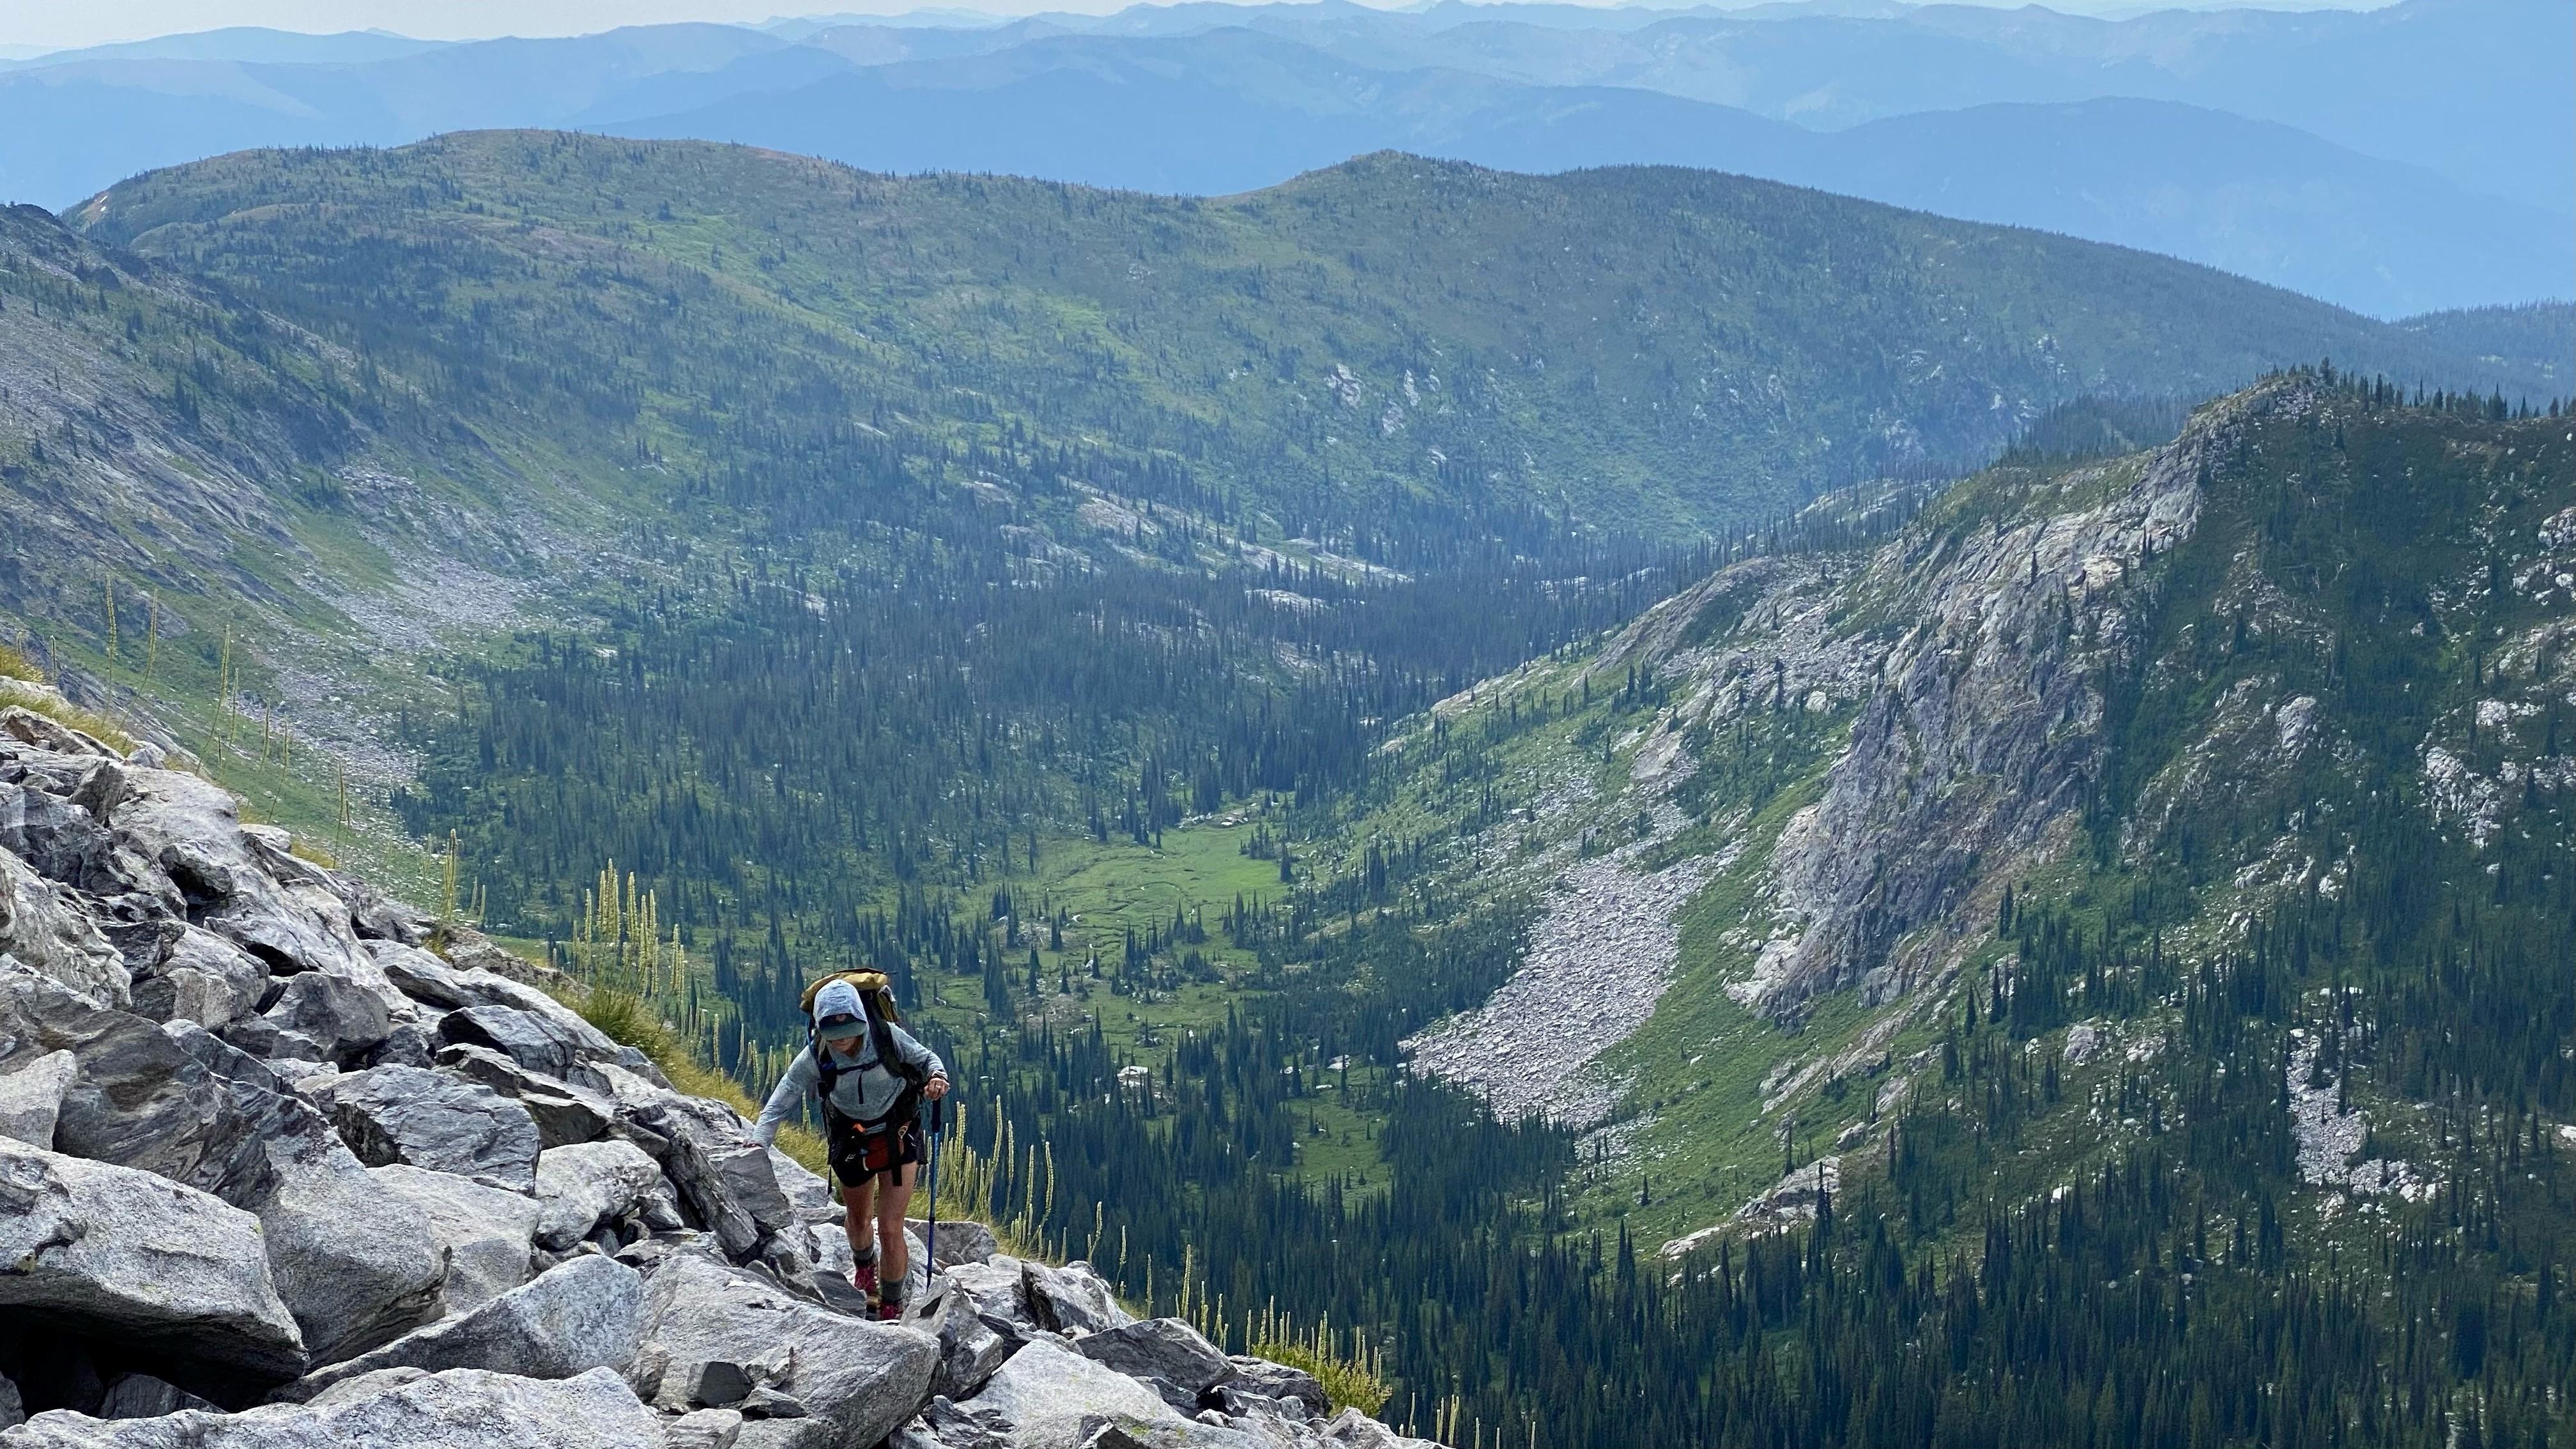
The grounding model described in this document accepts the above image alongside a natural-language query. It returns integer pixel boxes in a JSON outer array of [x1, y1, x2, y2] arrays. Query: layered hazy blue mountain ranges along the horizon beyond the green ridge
[[0, 0, 2576, 317]]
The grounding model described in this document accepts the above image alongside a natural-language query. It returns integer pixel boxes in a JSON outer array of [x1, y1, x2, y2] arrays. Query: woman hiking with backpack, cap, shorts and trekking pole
[[755, 980, 948, 1322]]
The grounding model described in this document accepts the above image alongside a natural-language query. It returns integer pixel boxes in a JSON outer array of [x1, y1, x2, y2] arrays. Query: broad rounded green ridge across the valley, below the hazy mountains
[[72, 132, 2527, 531]]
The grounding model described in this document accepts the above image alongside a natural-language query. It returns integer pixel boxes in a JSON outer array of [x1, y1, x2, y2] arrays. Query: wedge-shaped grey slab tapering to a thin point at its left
[[278, 1253, 644, 1400]]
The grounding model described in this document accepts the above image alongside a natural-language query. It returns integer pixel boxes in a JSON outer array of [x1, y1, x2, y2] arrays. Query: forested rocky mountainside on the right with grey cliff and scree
[[373, 374, 2576, 1446]]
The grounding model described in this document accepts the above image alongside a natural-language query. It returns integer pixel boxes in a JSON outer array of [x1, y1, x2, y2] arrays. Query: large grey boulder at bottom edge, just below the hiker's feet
[[634, 1255, 938, 1449]]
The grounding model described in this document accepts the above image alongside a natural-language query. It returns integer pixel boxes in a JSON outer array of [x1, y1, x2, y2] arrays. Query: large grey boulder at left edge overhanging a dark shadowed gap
[[0, 1140, 304, 1379]]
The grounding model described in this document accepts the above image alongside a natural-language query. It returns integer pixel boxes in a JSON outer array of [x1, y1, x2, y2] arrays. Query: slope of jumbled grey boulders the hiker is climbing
[[0, 709, 1425, 1449]]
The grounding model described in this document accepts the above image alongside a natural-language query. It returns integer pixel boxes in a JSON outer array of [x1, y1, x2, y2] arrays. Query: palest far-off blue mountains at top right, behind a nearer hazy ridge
[[1244, 0, 2576, 211]]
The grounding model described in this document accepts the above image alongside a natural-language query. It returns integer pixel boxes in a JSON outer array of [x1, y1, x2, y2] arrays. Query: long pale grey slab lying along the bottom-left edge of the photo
[[10, 1369, 664, 1449]]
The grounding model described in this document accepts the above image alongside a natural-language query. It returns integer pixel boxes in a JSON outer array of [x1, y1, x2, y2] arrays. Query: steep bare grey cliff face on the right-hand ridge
[[1731, 392, 2225, 1013]]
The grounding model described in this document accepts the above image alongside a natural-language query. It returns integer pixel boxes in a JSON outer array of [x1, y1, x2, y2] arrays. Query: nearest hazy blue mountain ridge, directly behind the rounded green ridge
[[585, 28, 2576, 317]]
